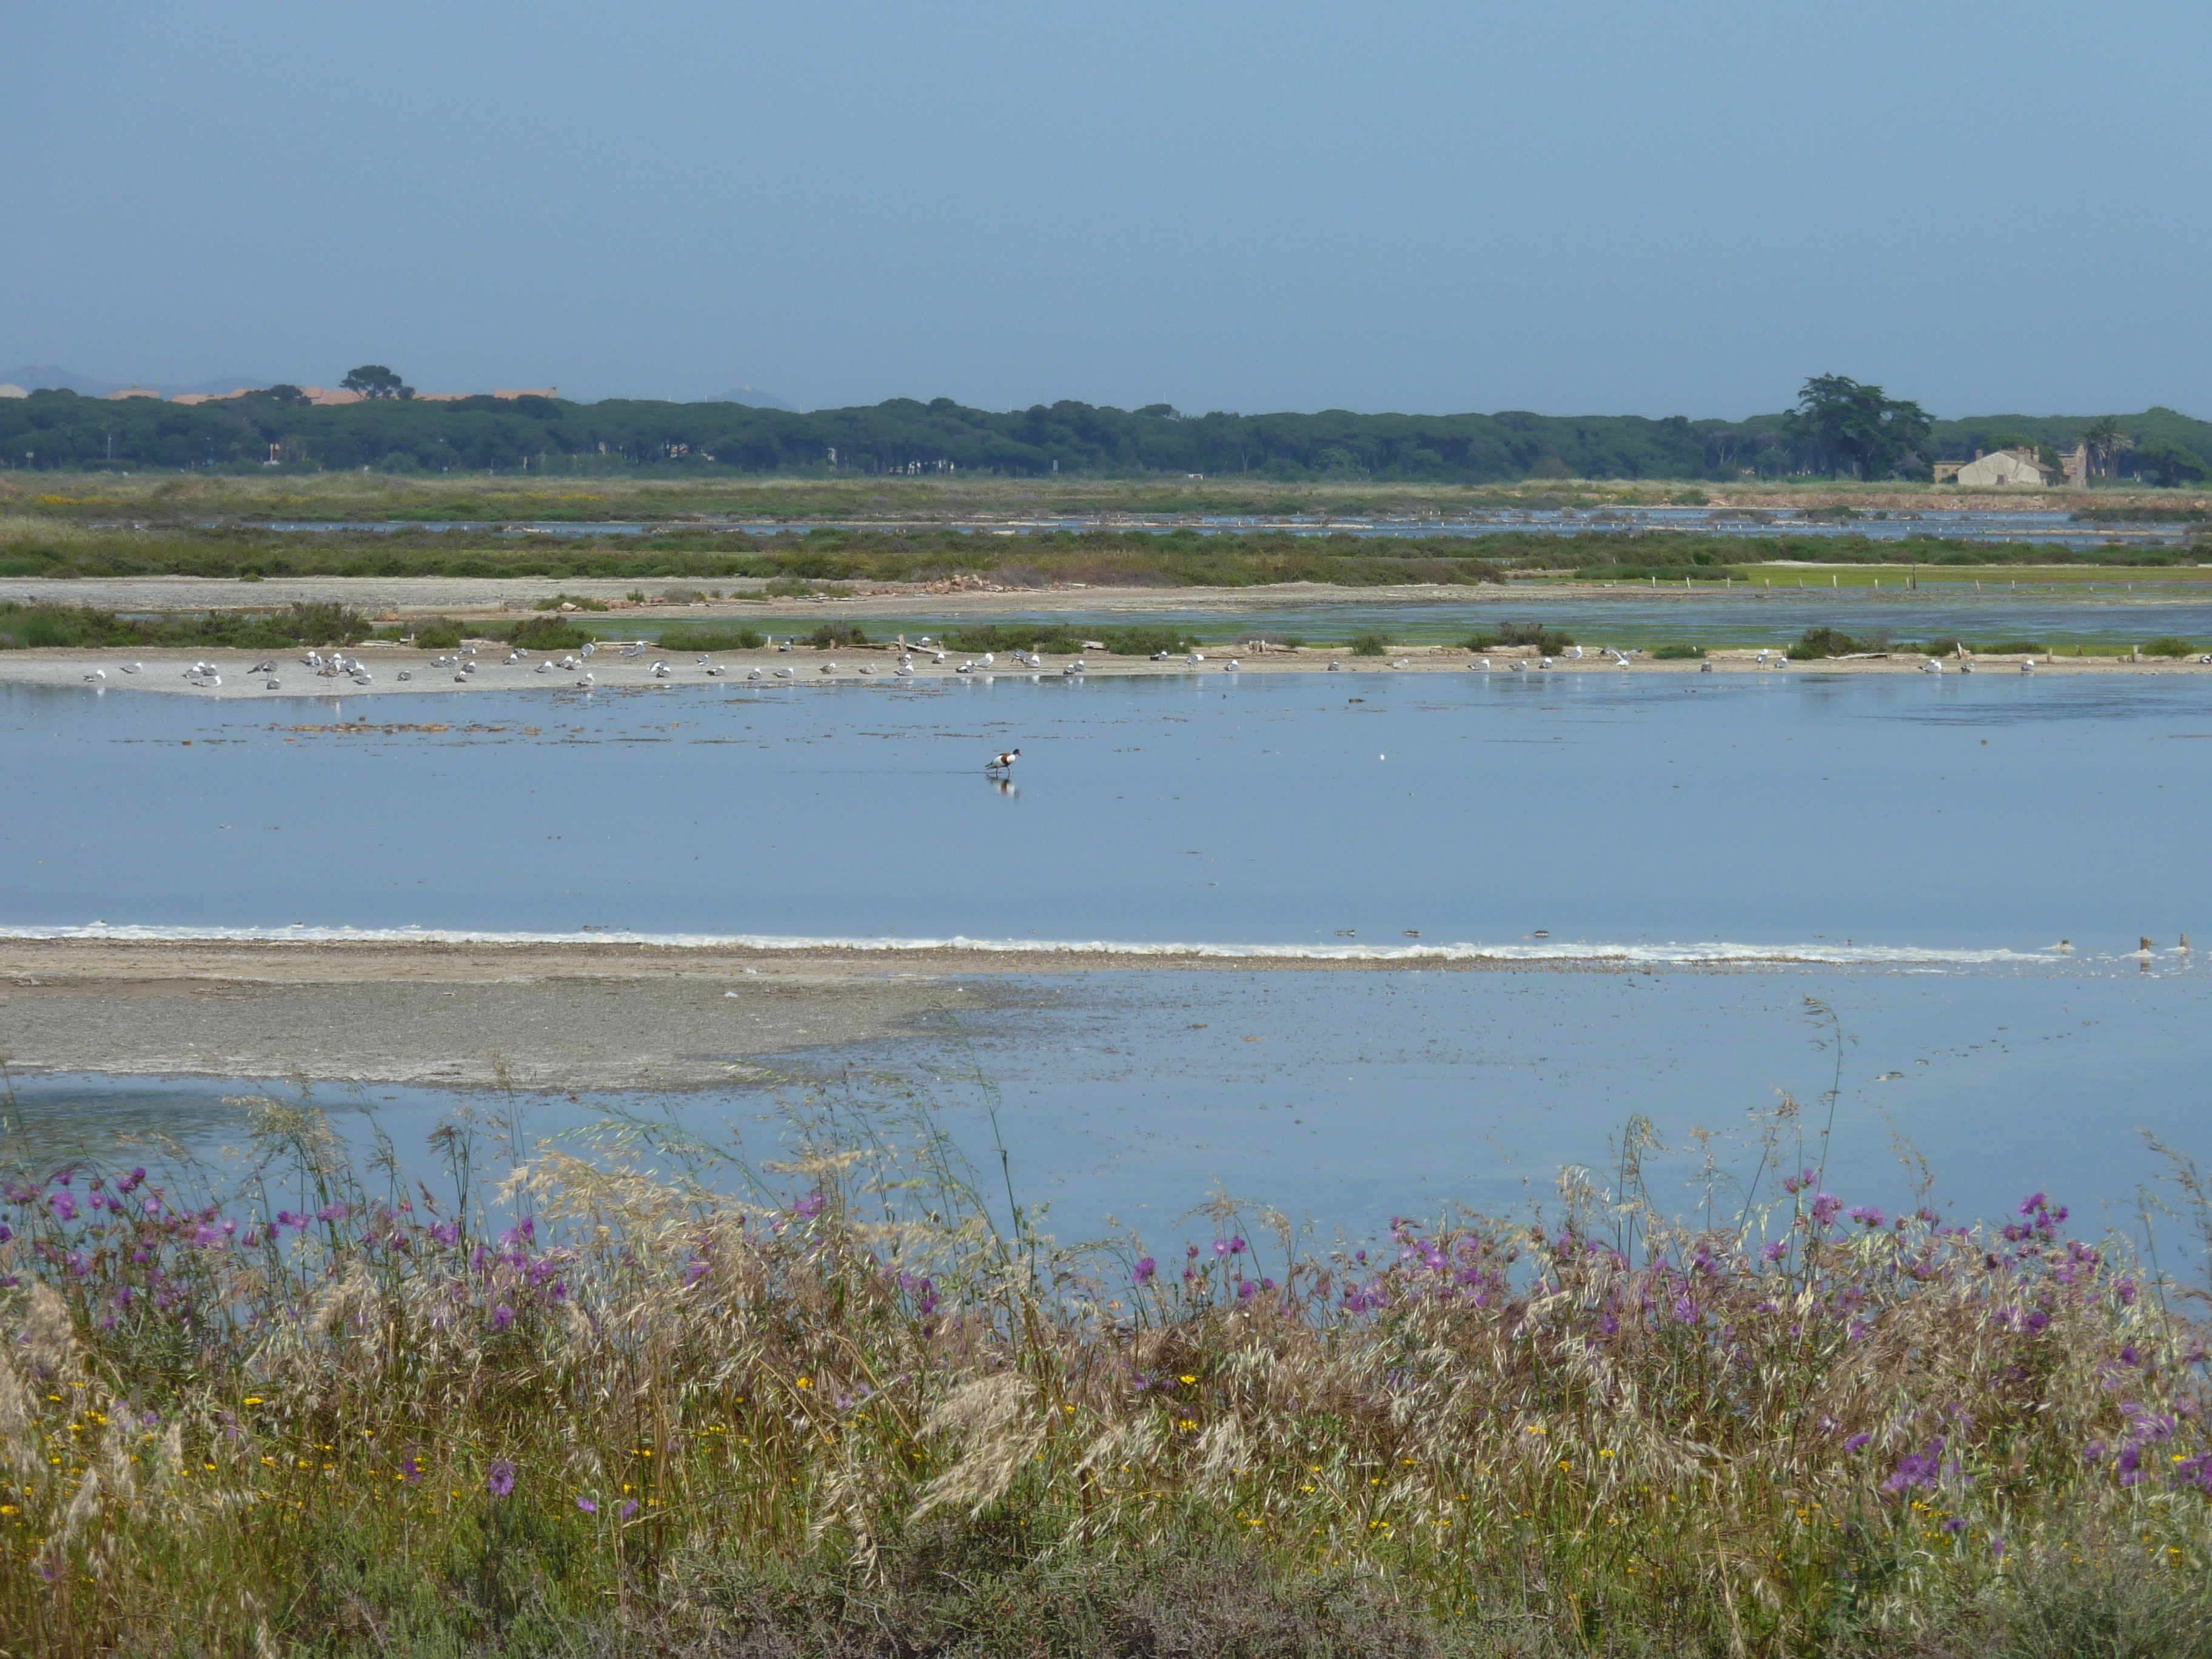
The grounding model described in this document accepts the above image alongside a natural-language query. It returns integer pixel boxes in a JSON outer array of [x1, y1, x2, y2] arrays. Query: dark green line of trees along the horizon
[[0, 376, 2212, 484]]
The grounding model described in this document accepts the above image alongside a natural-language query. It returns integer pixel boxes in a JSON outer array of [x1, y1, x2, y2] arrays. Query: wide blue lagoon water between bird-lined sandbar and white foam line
[[0, 670, 2212, 958]]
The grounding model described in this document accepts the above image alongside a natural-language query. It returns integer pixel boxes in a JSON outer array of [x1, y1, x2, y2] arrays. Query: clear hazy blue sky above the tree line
[[0, 0, 2212, 418]]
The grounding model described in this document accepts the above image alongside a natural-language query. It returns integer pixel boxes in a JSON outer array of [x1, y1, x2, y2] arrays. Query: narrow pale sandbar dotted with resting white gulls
[[0, 644, 2212, 701]]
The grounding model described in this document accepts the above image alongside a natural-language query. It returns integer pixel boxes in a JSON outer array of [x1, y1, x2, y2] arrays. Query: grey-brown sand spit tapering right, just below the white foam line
[[0, 938, 1624, 1090]]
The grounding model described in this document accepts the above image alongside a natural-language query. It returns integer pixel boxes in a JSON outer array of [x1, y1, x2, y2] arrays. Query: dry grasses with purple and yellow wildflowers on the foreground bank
[[0, 1079, 2212, 1657]]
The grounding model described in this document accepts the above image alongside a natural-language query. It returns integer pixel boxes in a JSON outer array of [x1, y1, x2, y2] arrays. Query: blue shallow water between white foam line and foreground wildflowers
[[16, 965, 2212, 1245]]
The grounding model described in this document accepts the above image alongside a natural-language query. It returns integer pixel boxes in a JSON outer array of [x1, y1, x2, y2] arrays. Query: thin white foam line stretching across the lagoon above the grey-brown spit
[[0, 922, 2083, 967]]
